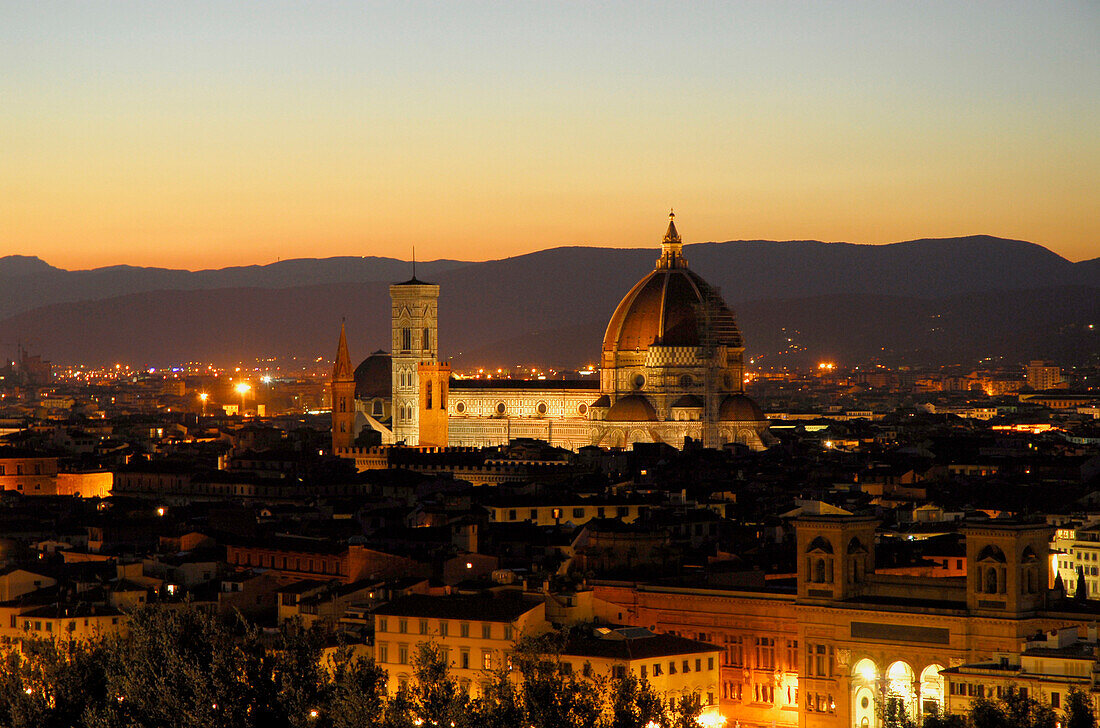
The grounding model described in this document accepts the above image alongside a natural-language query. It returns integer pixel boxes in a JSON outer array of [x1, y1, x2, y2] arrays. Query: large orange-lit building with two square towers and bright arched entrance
[[594, 515, 1100, 728]]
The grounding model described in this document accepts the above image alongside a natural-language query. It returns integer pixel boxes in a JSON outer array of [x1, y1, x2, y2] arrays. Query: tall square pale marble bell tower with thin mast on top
[[389, 274, 437, 445]]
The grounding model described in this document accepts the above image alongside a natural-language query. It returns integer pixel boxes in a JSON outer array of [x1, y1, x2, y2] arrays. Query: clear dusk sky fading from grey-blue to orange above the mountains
[[0, 0, 1100, 269]]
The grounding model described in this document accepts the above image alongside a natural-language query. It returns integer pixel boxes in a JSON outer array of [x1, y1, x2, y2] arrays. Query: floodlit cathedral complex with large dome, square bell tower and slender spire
[[330, 212, 772, 452]]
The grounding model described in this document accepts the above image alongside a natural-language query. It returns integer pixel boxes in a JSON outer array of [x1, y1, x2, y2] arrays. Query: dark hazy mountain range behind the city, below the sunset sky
[[0, 235, 1100, 366]]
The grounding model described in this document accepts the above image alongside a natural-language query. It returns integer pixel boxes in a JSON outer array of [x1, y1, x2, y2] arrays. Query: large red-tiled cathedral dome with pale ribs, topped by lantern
[[604, 214, 744, 352]]
